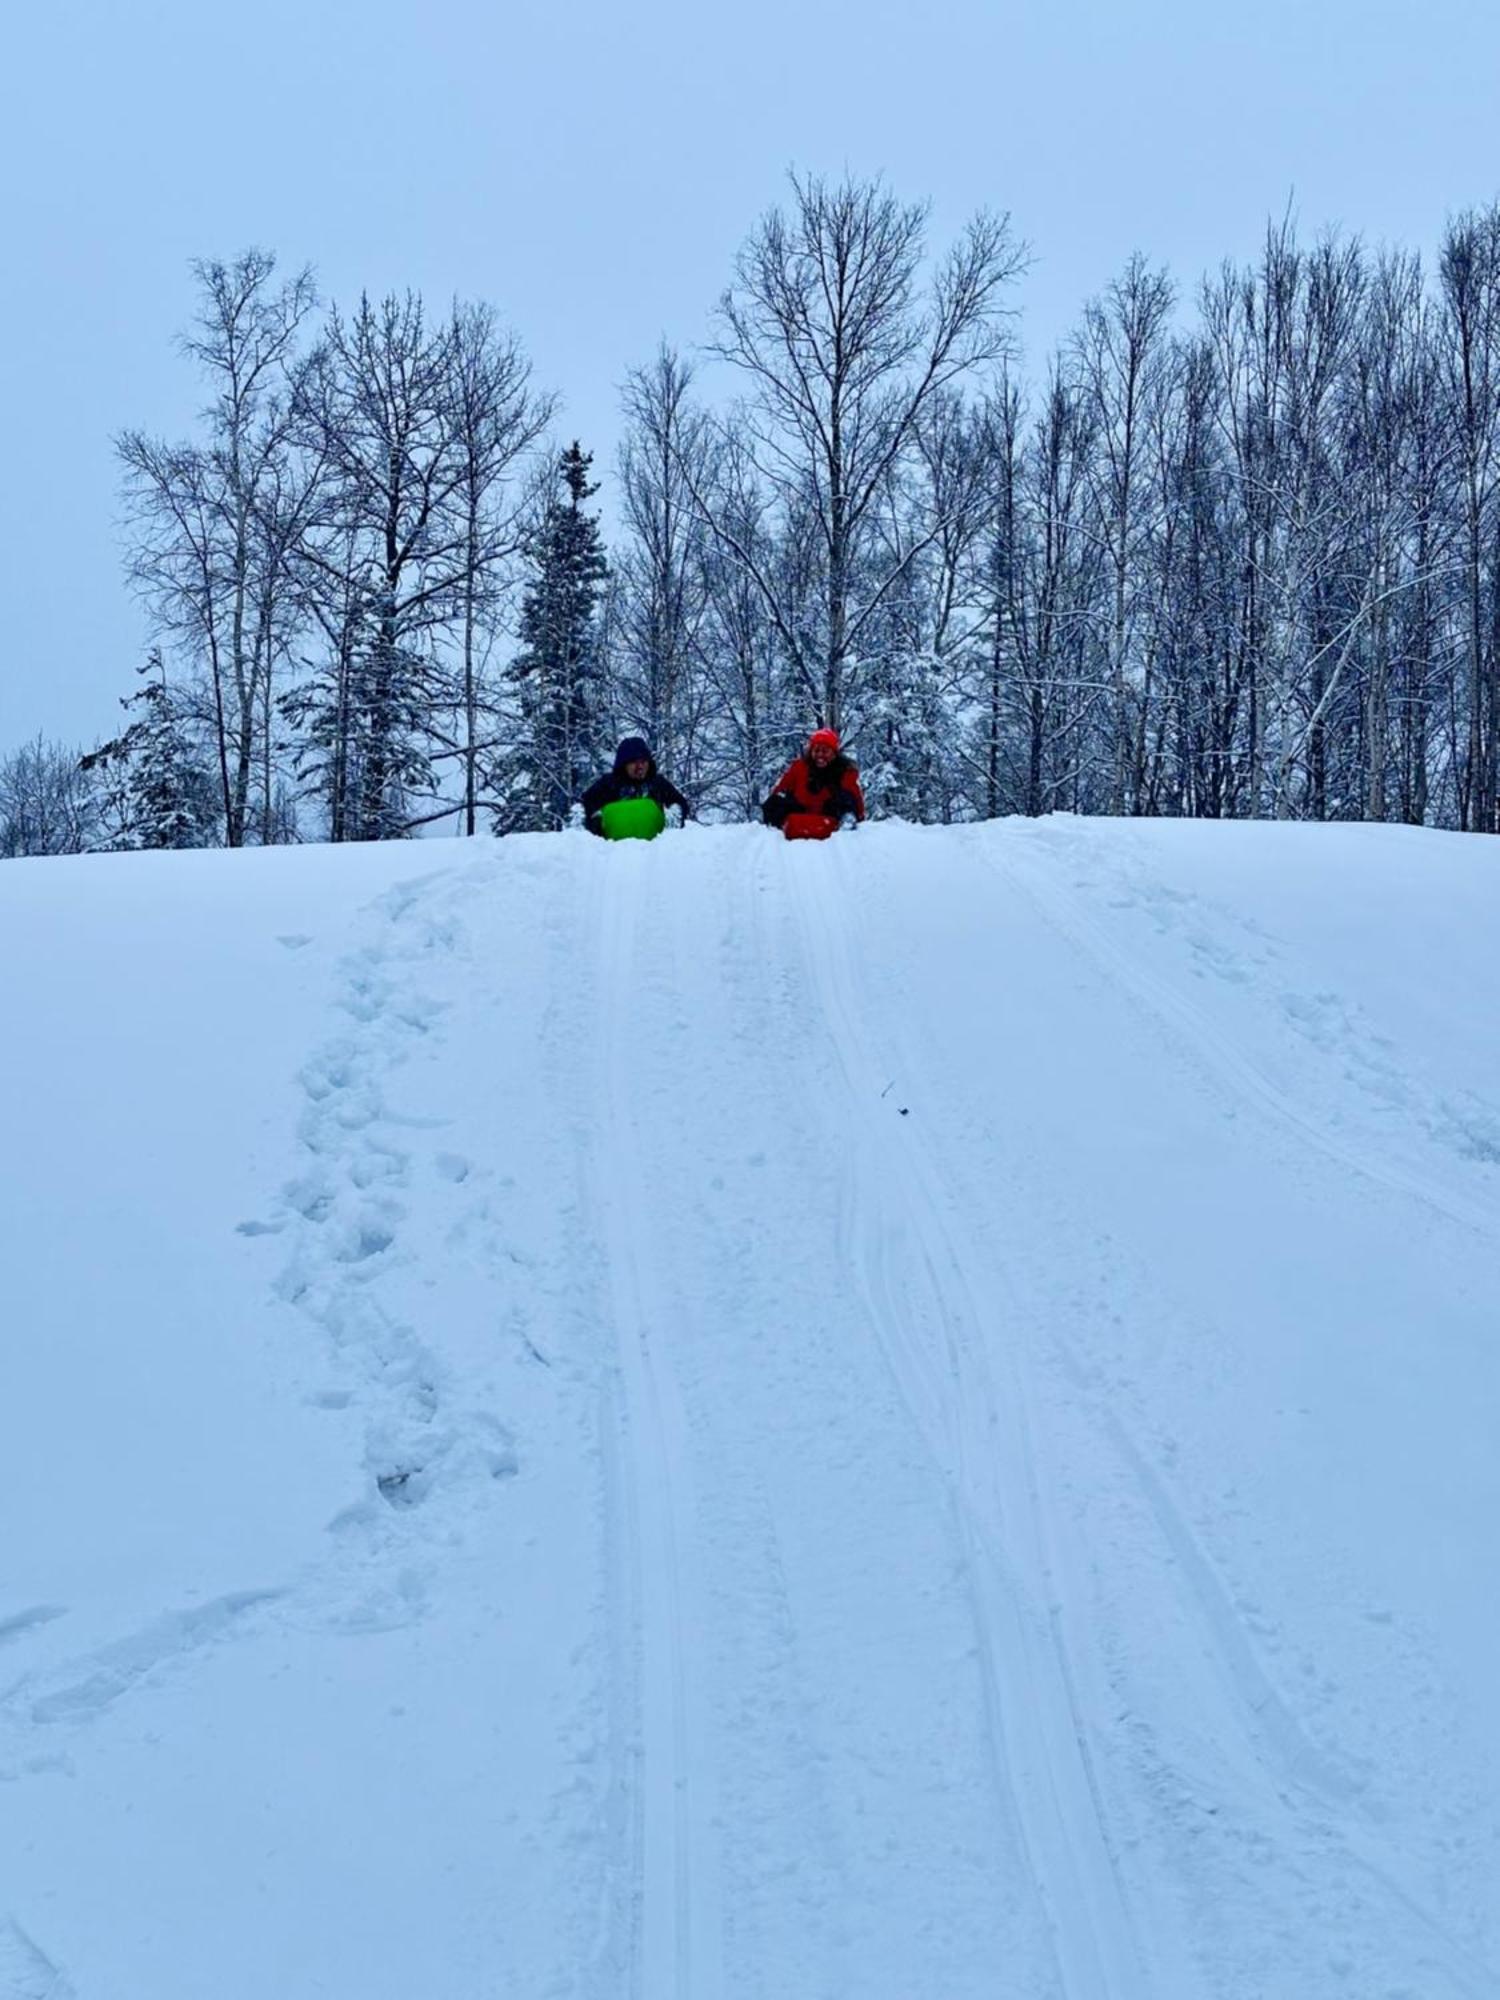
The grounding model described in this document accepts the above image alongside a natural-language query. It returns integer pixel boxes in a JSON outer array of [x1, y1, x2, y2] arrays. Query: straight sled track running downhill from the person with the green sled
[[592, 842, 720, 2000]]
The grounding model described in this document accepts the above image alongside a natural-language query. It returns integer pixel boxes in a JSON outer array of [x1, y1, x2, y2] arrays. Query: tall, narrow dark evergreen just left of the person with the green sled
[[496, 442, 608, 834]]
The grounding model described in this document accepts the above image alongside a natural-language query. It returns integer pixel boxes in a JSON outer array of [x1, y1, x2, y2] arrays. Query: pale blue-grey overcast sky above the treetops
[[0, 0, 1500, 752]]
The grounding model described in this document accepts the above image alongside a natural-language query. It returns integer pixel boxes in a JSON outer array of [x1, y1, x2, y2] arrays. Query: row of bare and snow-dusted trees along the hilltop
[[0, 176, 1500, 856]]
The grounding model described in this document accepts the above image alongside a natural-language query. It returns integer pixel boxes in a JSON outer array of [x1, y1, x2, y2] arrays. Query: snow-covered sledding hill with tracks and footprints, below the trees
[[0, 820, 1500, 2000]]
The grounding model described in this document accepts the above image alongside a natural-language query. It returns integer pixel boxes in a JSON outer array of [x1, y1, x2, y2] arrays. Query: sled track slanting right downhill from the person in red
[[790, 850, 1164, 2000]]
